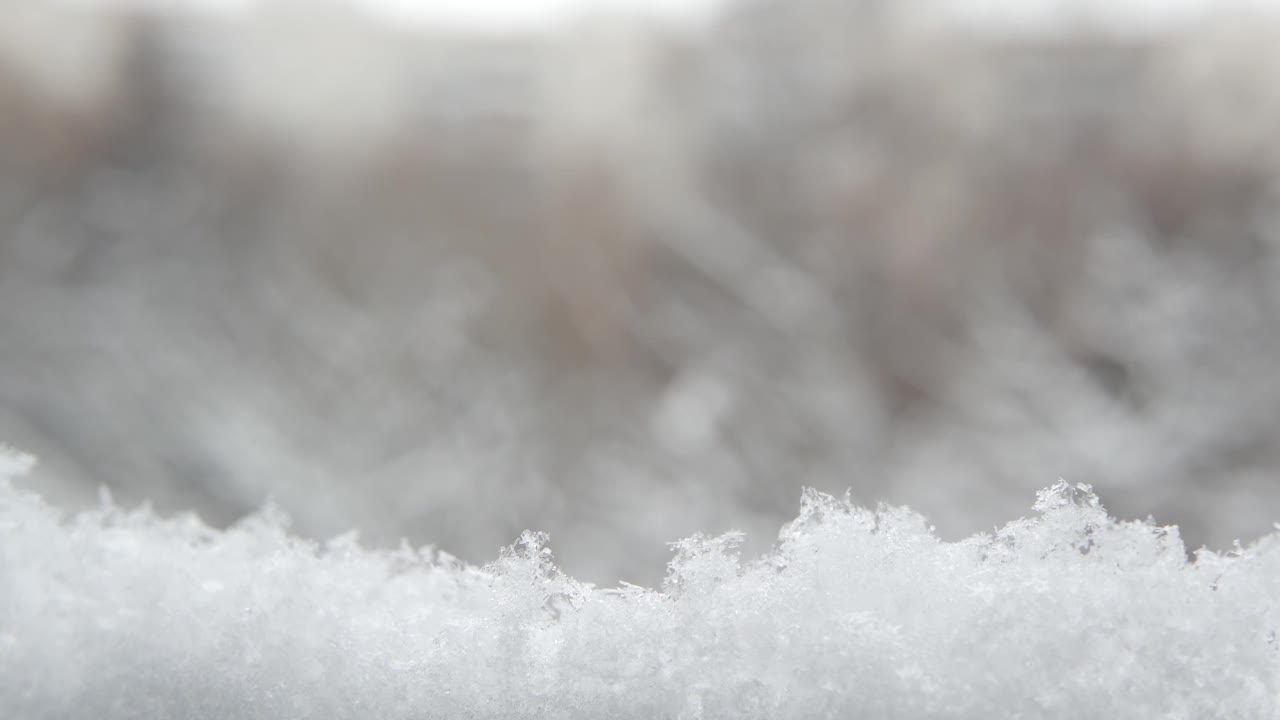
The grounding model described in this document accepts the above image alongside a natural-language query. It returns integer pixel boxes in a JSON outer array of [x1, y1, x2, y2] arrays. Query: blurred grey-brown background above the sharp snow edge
[[0, 0, 1280, 584]]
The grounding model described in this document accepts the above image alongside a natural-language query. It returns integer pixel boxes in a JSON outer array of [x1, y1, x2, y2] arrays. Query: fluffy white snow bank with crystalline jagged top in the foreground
[[0, 448, 1280, 719]]
